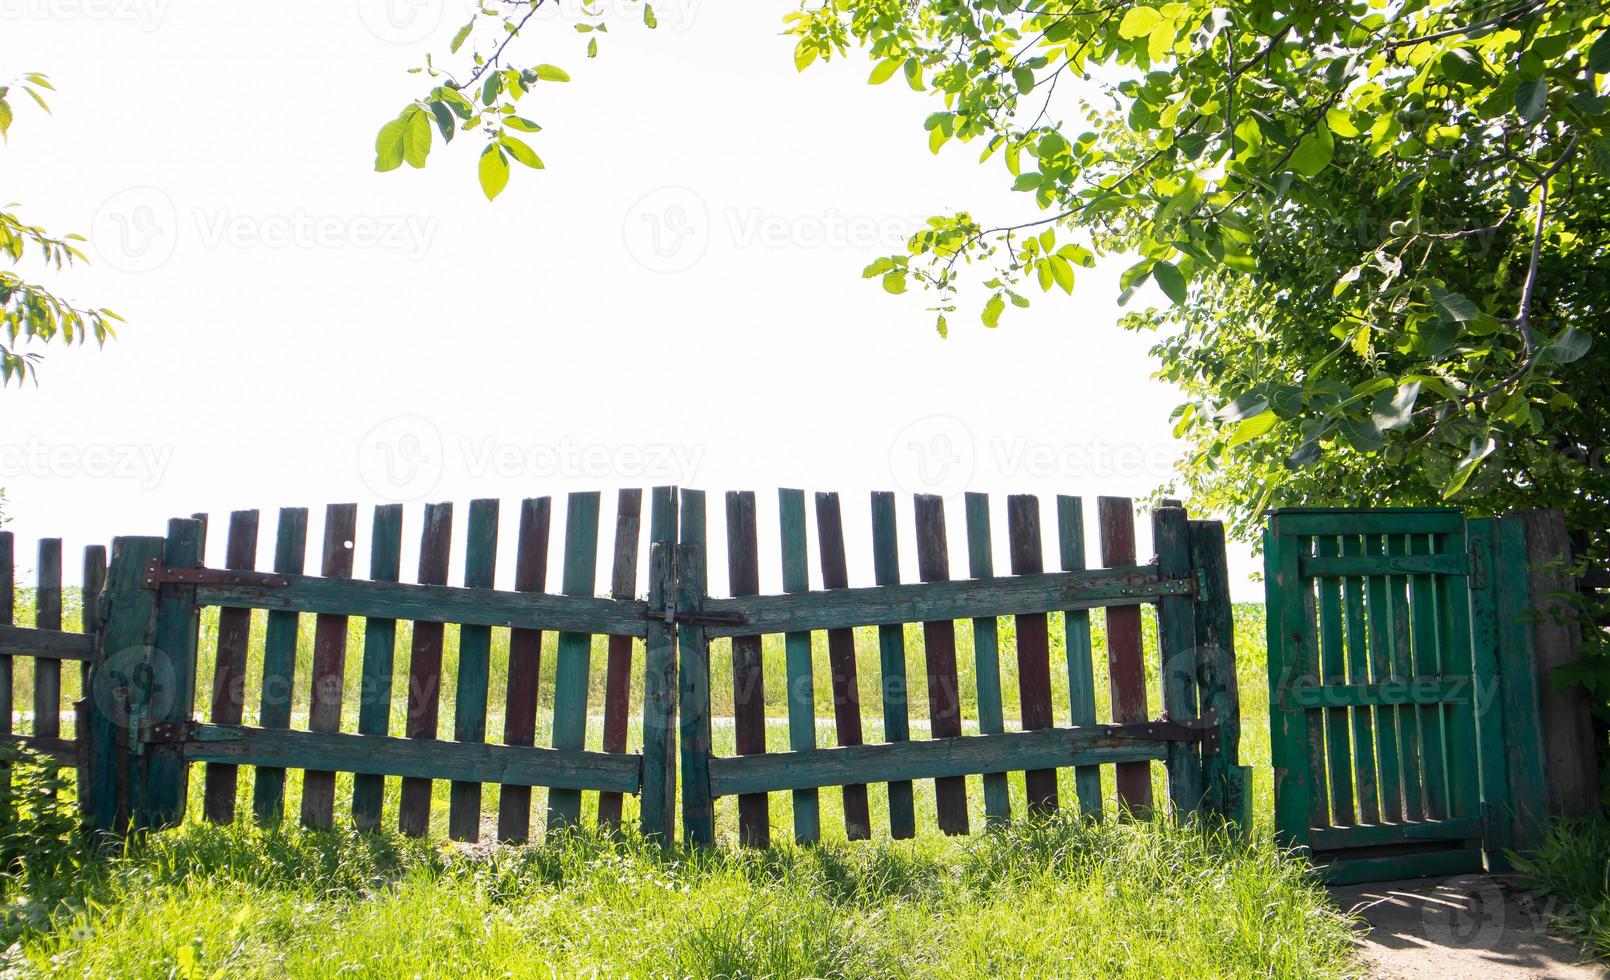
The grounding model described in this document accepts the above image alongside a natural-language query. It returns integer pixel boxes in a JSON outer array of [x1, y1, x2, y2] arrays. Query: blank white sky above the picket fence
[[0, 0, 1257, 599]]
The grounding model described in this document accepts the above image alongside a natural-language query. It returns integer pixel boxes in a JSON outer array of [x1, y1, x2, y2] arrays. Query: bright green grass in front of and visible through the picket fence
[[0, 585, 1354, 977]]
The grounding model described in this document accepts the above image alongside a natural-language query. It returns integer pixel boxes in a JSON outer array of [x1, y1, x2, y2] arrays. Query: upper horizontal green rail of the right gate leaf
[[705, 565, 1193, 637]]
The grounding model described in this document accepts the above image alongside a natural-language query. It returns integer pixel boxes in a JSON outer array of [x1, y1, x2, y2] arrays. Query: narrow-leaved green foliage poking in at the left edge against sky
[[0, 72, 122, 386]]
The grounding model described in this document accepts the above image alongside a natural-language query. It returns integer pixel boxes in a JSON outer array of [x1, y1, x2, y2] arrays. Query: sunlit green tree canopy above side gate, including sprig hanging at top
[[377, 0, 1610, 521]]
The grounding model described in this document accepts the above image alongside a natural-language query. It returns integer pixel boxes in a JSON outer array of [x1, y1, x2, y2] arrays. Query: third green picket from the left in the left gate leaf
[[448, 499, 497, 843]]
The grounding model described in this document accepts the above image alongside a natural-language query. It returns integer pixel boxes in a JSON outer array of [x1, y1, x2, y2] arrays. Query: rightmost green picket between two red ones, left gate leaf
[[547, 491, 602, 832]]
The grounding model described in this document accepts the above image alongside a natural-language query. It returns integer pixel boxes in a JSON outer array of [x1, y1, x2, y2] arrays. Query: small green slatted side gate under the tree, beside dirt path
[[1264, 509, 1547, 883]]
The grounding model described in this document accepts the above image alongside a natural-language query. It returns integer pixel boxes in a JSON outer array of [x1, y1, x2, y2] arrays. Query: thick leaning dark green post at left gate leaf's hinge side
[[79, 537, 164, 834]]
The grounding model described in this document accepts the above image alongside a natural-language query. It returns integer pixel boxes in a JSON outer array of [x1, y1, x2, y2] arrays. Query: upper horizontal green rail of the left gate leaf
[[196, 574, 647, 634]]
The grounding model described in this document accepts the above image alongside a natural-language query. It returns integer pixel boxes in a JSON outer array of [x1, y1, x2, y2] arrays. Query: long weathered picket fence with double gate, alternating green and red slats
[[0, 488, 1246, 845]]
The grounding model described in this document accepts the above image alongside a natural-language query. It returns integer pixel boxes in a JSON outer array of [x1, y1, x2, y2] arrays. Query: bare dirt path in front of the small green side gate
[[1331, 875, 1610, 980]]
